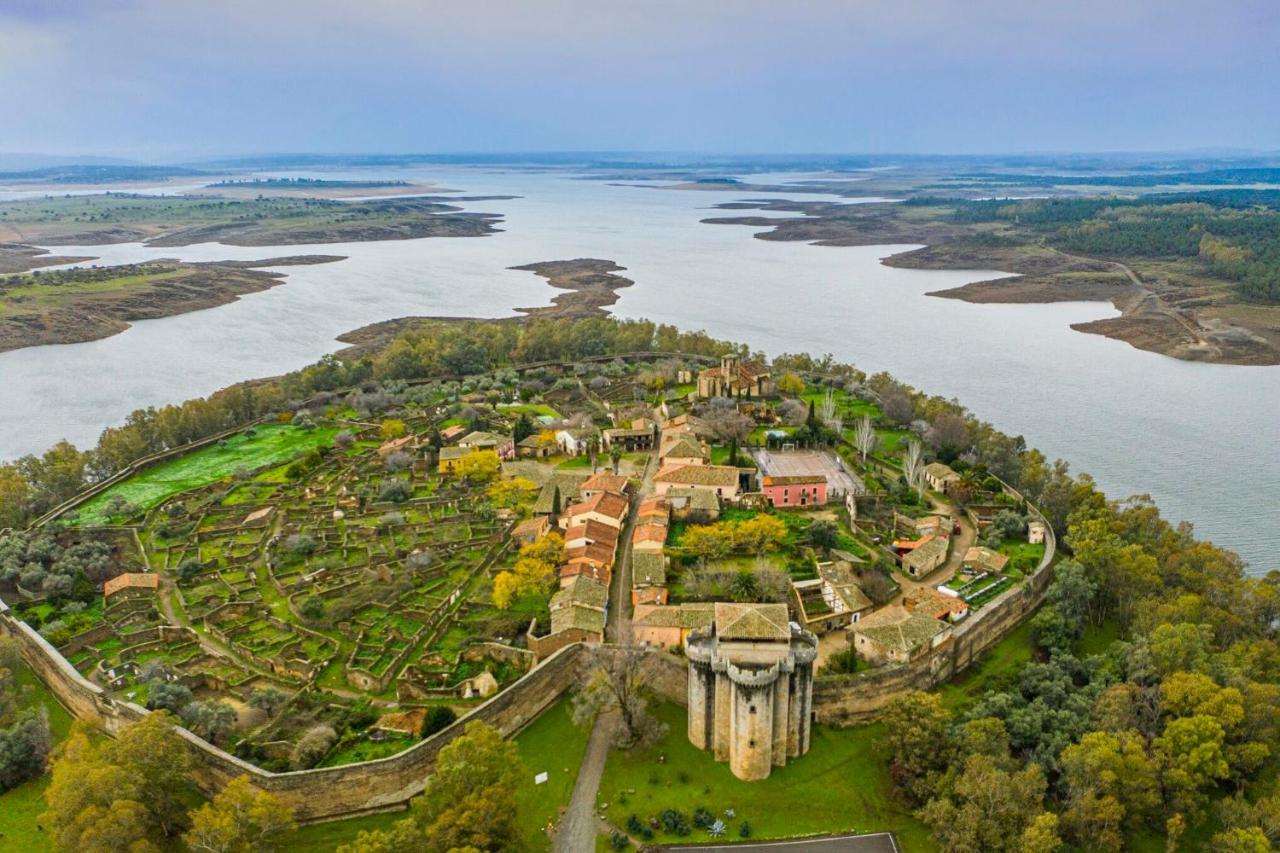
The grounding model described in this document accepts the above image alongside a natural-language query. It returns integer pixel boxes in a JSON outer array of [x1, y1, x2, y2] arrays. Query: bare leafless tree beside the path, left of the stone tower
[[573, 646, 667, 749]]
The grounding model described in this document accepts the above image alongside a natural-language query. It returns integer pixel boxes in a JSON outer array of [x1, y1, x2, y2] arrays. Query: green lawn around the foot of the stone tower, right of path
[[599, 704, 936, 853]]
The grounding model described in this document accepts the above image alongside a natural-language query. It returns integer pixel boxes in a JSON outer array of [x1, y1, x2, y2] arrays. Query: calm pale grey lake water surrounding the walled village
[[0, 169, 1280, 571]]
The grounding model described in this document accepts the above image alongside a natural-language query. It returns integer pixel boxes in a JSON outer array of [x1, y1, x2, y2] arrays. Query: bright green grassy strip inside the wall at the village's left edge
[[78, 424, 338, 525]]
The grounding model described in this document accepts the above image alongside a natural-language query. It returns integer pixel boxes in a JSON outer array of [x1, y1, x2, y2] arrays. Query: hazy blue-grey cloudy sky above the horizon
[[0, 0, 1280, 160]]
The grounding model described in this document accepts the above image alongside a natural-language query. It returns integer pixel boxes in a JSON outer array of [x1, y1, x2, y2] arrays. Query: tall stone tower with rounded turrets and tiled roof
[[686, 603, 818, 781]]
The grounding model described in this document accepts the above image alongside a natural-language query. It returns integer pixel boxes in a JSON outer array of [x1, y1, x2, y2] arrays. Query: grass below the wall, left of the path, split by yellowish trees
[[280, 698, 589, 853]]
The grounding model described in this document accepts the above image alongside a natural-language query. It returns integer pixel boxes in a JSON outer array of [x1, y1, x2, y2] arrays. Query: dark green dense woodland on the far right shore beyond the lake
[[942, 190, 1280, 304]]
